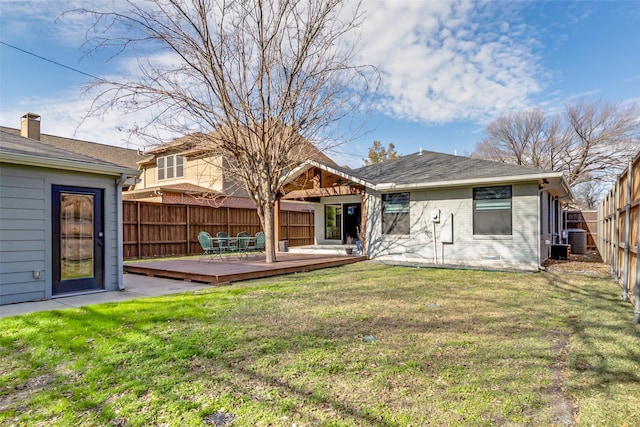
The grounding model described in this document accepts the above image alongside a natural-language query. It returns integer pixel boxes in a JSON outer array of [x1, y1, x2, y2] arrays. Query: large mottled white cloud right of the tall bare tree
[[361, 0, 542, 124]]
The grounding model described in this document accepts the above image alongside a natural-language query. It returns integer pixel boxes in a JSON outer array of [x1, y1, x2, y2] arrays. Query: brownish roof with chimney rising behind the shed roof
[[0, 126, 145, 169]]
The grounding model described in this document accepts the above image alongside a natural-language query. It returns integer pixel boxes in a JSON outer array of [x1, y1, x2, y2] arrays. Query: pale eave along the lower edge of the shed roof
[[2, 153, 142, 178]]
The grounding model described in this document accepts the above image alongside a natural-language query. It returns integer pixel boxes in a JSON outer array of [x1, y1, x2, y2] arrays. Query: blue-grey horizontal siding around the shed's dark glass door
[[0, 163, 119, 304]]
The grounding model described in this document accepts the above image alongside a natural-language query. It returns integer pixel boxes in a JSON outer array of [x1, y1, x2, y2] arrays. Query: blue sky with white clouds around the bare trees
[[0, 0, 640, 167]]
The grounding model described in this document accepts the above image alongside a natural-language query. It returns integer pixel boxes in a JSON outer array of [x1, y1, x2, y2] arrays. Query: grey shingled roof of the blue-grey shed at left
[[0, 129, 140, 177]]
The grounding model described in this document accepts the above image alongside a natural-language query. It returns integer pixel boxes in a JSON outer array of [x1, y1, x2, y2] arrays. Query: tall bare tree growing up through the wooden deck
[[73, 0, 377, 263]]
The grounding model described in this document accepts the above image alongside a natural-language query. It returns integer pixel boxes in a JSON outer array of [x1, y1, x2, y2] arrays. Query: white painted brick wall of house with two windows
[[367, 183, 539, 270]]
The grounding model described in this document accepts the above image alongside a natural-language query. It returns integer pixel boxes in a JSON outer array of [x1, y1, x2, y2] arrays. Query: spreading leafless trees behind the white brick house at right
[[475, 100, 640, 206]]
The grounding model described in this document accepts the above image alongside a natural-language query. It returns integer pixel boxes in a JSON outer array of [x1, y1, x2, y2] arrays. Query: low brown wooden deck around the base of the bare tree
[[124, 253, 366, 285]]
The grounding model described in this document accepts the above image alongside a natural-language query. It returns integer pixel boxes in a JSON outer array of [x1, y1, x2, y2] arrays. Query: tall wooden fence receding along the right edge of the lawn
[[598, 152, 640, 324]]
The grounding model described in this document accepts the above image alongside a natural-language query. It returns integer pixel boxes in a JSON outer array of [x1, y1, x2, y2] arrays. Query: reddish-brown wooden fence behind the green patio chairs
[[122, 200, 314, 259]]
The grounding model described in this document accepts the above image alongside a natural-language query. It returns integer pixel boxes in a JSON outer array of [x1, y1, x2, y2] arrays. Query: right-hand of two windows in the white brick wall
[[473, 185, 511, 236]]
